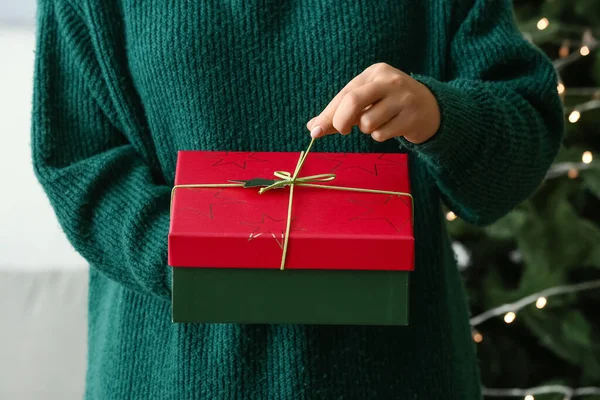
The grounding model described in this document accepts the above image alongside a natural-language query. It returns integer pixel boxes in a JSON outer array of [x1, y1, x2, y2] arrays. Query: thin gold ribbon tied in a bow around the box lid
[[171, 138, 414, 271]]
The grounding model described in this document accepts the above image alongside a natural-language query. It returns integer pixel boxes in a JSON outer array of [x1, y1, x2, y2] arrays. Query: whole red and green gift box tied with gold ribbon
[[169, 143, 414, 325]]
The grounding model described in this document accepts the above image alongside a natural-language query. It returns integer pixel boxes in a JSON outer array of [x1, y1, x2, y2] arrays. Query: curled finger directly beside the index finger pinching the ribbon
[[332, 82, 391, 135]]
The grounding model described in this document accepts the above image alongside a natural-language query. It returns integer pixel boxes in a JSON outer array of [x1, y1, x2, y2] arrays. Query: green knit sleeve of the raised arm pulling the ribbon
[[399, 0, 564, 225]]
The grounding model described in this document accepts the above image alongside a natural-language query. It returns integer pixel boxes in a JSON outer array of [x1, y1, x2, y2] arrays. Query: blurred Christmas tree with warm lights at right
[[447, 0, 600, 400]]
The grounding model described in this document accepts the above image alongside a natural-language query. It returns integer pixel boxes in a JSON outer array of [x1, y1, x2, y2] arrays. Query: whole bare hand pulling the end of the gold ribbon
[[306, 63, 441, 143]]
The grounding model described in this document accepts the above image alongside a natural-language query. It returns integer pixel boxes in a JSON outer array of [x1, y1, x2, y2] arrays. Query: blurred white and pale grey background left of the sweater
[[0, 0, 88, 400]]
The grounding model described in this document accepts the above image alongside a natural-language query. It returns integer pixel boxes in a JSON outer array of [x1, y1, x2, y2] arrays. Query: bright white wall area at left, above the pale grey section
[[0, 26, 85, 270]]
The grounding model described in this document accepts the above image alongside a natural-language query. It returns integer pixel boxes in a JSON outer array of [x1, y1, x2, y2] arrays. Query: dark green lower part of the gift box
[[172, 268, 410, 325]]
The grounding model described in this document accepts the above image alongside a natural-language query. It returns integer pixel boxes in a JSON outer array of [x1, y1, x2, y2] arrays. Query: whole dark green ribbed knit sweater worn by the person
[[32, 0, 563, 400]]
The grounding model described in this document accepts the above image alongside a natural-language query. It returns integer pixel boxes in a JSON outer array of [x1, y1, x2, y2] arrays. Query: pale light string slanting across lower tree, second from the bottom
[[470, 279, 600, 326]]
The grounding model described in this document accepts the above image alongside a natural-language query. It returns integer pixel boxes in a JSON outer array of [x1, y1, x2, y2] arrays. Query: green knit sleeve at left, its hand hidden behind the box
[[31, 0, 171, 300]]
